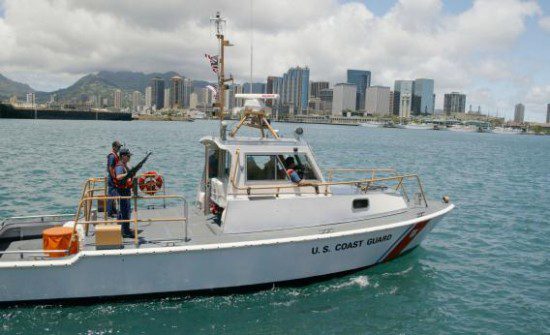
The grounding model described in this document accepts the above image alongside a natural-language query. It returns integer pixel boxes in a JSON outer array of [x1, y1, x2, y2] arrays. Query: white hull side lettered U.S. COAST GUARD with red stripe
[[0, 205, 453, 303]]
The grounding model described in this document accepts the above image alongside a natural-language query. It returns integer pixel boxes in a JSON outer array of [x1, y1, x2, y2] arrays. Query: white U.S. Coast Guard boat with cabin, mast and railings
[[0, 12, 454, 303]]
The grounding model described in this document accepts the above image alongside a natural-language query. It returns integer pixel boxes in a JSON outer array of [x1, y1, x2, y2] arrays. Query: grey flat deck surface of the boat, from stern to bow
[[0, 201, 449, 261]]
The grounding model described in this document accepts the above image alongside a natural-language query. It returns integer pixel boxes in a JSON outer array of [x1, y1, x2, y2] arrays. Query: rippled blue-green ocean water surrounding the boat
[[0, 120, 550, 334]]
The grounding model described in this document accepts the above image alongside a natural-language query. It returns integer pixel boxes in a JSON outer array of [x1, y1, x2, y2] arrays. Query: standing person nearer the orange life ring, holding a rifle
[[114, 148, 134, 238]]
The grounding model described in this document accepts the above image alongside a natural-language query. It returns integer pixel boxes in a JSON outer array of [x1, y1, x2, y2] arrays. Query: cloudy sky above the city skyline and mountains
[[0, 0, 550, 122]]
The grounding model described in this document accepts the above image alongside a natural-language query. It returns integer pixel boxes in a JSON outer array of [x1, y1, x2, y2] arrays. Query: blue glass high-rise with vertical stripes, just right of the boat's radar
[[281, 66, 309, 115]]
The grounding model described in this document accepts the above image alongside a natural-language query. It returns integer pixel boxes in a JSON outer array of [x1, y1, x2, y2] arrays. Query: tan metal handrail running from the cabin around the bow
[[230, 149, 428, 207]]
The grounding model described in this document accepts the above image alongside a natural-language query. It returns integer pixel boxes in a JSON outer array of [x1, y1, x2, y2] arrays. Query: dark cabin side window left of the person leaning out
[[246, 155, 288, 181]]
